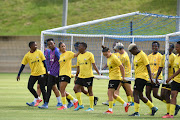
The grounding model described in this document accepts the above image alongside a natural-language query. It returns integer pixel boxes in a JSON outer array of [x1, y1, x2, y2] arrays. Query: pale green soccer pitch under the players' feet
[[0, 73, 180, 120]]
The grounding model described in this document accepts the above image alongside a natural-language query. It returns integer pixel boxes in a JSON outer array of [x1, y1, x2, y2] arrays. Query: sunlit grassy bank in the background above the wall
[[0, 0, 177, 35]]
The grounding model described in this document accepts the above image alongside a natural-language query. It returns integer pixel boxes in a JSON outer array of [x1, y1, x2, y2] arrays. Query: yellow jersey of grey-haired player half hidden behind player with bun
[[120, 52, 131, 77]]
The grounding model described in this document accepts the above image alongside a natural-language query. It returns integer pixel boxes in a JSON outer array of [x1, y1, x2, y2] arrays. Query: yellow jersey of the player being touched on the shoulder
[[77, 51, 95, 78]]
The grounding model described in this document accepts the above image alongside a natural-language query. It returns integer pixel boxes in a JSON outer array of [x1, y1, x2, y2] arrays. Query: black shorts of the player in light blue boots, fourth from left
[[75, 77, 93, 87]]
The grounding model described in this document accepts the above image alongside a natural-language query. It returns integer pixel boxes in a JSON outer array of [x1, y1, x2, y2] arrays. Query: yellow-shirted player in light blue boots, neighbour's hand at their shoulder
[[74, 42, 99, 111]]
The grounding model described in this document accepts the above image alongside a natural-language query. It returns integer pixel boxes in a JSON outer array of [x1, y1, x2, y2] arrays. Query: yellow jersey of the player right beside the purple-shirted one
[[59, 51, 74, 78]]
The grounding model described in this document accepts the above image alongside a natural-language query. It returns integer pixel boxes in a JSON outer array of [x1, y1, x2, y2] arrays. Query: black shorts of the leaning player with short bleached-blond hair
[[134, 78, 147, 92]]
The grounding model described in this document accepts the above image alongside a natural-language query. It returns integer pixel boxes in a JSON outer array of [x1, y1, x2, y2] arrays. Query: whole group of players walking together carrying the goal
[[17, 38, 180, 118]]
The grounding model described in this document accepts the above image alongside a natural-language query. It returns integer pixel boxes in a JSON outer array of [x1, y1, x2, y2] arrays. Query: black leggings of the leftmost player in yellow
[[28, 75, 46, 101]]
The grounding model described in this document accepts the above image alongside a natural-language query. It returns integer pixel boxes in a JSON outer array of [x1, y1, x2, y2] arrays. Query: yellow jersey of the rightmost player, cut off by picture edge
[[173, 55, 180, 83]]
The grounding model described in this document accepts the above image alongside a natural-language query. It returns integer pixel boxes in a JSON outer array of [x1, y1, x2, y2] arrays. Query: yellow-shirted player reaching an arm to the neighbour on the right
[[58, 42, 79, 110]]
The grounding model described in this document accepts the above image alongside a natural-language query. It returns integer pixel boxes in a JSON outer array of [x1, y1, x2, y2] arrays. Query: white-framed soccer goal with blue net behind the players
[[41, 12, 180, 79]]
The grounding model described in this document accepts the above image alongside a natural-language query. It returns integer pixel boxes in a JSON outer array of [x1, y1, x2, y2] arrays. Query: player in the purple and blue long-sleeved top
[[39, 38, 62, 109]]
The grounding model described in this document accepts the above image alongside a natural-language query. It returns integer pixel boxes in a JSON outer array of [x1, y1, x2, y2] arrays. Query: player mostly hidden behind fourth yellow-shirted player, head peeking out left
[[72, 42, 99, 105]]
